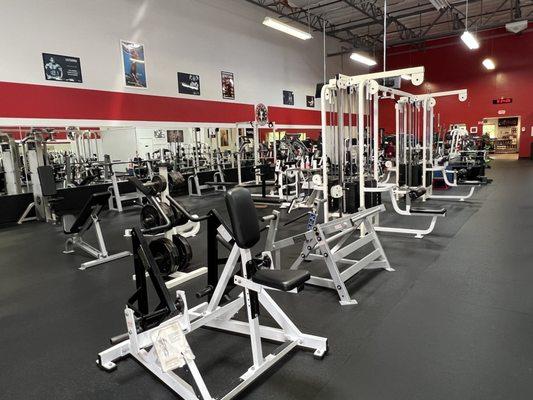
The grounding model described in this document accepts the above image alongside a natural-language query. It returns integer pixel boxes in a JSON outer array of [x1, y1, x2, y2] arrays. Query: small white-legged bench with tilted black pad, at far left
[[61, 192, 131, 270]]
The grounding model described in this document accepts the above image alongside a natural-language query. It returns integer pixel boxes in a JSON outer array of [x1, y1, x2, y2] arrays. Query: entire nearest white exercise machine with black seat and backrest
[[97, 188, 327, 400]]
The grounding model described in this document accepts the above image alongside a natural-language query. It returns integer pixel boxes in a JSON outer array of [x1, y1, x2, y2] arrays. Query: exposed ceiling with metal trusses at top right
[[245, 0, 533, 56]]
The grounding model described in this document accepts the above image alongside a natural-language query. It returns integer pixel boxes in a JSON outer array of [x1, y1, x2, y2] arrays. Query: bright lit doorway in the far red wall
[[483, 116, 521, 154]]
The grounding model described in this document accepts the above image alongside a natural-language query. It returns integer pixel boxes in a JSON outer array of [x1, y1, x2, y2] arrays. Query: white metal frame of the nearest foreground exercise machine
[[97, 225, 327, 400]]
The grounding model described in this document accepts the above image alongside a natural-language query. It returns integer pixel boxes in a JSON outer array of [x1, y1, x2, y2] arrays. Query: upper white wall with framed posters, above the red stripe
[[0, 0, 366, 108]]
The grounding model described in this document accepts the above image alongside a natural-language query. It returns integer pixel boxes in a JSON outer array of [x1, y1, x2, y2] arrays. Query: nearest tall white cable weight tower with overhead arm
[[321, 67, 446, 238]]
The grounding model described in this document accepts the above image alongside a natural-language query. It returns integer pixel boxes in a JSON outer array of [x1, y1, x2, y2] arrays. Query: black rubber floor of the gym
[[0, 160, 533, 400]]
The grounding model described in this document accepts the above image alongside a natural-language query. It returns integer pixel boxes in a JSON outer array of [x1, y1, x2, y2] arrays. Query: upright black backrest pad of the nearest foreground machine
[[226, 188, 261, 249]]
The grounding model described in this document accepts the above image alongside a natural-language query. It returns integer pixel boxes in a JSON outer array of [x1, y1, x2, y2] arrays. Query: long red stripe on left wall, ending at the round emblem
[[0, 82, 254, 123]]
